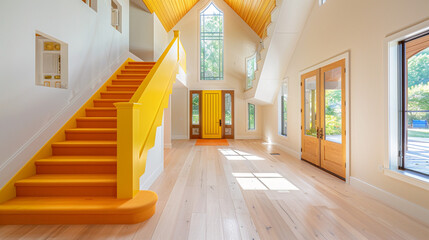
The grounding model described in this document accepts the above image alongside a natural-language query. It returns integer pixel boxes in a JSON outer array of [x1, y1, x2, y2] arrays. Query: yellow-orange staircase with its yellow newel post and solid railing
[[0, 32, 186, 224]]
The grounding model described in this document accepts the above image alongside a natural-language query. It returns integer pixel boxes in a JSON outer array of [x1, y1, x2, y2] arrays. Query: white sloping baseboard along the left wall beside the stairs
[[0, 52, 131, 188]]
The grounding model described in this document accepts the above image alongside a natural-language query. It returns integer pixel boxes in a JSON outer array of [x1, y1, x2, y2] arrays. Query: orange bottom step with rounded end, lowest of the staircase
[[0, 191, 158, 225]]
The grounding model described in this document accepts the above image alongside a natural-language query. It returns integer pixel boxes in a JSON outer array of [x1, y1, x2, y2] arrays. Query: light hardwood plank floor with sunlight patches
[[0, 140, 429, 240]]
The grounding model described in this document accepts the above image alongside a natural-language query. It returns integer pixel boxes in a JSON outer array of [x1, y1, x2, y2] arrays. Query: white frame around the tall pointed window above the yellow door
[[197, 1, 226, 84]]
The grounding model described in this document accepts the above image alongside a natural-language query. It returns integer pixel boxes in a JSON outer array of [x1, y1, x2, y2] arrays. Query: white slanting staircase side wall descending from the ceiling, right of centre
[[245, 0, 317, 104]]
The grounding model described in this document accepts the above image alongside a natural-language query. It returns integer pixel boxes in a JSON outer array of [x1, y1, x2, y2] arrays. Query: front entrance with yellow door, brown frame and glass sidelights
[[189, 90, 234, 139]]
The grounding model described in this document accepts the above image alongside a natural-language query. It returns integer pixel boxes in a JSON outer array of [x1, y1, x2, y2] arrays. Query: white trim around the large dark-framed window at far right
[[380, 20, 429, 190]]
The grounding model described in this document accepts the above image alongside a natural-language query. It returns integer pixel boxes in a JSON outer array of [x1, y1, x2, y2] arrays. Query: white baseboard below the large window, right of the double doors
[[350, 177, 429, 226]]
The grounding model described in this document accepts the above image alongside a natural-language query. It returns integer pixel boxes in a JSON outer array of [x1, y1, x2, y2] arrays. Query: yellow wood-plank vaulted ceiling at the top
[[143, 0, 276, 38]]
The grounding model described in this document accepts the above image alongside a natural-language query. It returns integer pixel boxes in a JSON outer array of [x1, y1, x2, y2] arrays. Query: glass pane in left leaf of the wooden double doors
[[304, 76, 317, 137]]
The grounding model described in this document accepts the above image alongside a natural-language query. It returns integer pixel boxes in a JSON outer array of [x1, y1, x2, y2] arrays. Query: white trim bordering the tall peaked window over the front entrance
[[197, 1, 226, 84]]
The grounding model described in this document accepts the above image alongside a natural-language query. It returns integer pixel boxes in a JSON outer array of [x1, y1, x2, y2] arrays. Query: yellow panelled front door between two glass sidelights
[[202, 90, 222, 138]]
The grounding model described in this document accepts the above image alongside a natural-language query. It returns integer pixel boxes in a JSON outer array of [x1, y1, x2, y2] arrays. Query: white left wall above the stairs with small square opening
[[0, 0, 129, 187]]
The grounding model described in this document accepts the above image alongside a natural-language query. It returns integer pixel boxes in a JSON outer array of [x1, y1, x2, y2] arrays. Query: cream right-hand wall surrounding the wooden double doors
[[263, 0, 429, 210]]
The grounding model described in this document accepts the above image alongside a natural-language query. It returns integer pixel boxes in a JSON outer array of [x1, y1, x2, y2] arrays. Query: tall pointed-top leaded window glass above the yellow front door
[[200, 3, 223, 80]]
